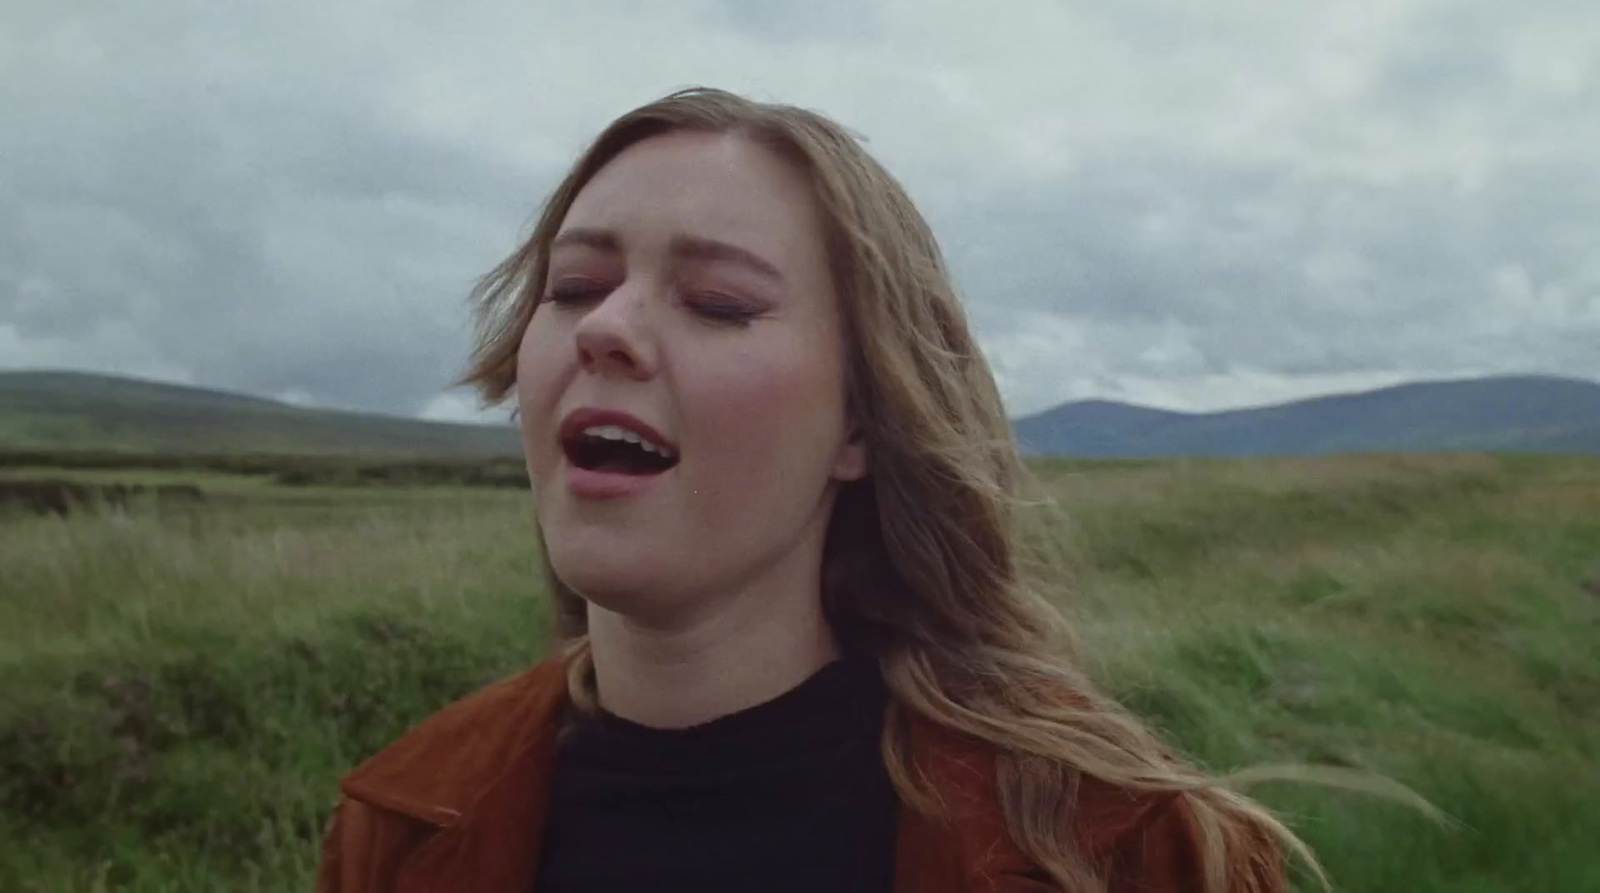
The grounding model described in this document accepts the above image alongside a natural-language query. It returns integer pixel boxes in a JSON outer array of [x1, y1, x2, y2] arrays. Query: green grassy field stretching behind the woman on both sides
[[0, 456, 1600, 893]]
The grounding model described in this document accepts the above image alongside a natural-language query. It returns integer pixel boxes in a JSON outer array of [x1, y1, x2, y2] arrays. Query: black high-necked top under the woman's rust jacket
[[536, 659, 899, 893]]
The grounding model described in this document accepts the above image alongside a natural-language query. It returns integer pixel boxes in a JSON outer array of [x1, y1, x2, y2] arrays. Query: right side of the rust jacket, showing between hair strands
[[910, 720, 1282, 893]]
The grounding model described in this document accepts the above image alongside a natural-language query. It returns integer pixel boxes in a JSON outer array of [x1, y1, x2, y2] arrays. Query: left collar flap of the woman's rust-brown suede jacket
[[339, 658, 566, 824]]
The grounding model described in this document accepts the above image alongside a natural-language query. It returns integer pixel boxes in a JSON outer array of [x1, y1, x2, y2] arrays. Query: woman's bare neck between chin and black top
[[589, 569, 838, 728]]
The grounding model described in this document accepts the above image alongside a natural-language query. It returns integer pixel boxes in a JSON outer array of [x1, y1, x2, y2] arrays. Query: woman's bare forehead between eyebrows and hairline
[[562, 131, 826, 267]]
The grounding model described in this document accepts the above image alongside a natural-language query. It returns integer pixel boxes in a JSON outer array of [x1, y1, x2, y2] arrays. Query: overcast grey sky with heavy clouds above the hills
[[0, 0, 1600, 418]]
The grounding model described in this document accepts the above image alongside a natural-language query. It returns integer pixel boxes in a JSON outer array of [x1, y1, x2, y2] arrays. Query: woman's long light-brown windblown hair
[[464, 88, 1320, 893]]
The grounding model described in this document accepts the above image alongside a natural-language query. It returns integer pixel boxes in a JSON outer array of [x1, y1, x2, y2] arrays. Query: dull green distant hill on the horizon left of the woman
[[0, 371, 522, 456]]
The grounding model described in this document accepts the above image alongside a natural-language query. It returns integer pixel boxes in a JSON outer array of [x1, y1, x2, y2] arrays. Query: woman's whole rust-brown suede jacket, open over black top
[[317, 659, 1282, 893]]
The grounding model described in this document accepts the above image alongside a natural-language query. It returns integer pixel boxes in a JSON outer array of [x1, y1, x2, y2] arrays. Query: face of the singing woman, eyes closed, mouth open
[[517, 133, 866, 619]]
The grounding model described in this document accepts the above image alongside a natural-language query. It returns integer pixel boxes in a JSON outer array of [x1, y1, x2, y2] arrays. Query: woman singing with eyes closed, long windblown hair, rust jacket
[[320, 90, 1304, 893]]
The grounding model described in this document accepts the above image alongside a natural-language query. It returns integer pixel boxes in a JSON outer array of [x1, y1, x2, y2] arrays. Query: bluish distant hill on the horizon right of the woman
[[1016, 376, 1600, 458]]
